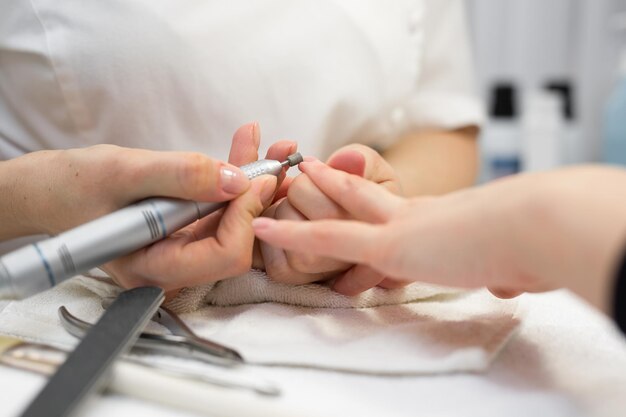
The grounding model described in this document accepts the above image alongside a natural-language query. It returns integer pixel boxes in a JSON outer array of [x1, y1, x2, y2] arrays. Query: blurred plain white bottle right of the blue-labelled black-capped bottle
[[522, 90, 565, 172]]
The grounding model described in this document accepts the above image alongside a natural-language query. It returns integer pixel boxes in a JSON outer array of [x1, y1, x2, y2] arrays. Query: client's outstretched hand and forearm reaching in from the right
[[253, 158, 626, 312]]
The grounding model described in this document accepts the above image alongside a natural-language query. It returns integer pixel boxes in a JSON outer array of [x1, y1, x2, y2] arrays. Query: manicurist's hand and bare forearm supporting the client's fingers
[[254, 127, 478, 295]]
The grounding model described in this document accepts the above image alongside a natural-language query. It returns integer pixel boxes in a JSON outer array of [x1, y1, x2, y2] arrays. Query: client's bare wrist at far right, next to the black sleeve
[[516, 167, 626, 312]]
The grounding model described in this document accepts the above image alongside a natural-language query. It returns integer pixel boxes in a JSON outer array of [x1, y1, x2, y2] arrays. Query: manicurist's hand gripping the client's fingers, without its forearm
[[254, 145, 403, 295]]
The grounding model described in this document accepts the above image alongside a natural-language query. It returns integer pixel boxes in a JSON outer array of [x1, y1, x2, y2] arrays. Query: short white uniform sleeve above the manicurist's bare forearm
[[406, 0, 484, 129]]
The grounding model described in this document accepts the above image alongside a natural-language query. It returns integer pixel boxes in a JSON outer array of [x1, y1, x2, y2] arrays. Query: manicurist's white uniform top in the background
[[0, 0, 482, 159]]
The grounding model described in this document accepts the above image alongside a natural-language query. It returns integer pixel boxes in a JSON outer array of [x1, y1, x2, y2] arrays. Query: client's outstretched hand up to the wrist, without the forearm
[[253, 161, 558, 297]]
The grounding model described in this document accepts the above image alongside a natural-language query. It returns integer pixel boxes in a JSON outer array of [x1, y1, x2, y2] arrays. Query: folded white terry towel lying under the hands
[[0, 272, 519, 375]]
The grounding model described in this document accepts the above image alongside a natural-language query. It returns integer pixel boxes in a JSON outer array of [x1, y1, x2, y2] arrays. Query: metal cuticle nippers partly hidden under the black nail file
[[59, 298, 244, 366]]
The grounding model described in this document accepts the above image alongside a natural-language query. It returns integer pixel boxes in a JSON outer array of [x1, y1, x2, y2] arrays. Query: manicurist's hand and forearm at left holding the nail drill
[[0, 124, 296, 291]]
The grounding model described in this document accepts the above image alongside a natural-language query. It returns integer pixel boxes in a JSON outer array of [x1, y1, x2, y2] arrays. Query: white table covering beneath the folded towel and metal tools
[[0, 291, 626, 417]]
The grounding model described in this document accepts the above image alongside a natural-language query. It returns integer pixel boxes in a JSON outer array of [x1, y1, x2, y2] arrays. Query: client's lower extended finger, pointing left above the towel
[[252, 217, 379, 263]]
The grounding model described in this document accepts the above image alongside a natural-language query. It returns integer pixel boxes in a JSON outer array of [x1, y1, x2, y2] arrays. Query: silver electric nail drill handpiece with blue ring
[[0, 153, 302, 298]]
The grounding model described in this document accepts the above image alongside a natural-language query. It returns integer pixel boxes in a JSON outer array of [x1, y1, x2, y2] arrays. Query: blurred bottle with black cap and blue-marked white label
[[481, 82, 520, 182]]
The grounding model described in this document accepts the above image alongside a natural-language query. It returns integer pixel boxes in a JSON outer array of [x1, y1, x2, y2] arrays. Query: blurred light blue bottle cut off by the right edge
[[602, 13, 626, 165]]
